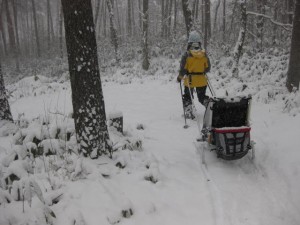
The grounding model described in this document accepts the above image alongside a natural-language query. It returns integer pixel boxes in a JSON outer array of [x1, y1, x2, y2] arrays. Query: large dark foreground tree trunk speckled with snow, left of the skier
[[62, 0, 111, 158]]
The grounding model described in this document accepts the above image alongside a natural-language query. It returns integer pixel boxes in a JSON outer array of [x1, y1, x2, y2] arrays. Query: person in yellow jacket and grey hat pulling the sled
[[177, 31, 210, 119]]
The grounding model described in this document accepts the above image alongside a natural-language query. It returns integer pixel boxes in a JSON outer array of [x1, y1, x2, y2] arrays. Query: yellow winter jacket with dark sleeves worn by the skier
[[179, 50, 210, 88]]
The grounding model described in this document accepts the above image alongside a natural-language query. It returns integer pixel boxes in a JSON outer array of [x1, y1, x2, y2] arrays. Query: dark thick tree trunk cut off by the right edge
[[286, 0, 300, 92]]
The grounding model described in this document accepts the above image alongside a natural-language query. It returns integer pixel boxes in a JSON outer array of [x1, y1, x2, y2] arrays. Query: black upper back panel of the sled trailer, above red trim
[[211, 98, 249, 128]]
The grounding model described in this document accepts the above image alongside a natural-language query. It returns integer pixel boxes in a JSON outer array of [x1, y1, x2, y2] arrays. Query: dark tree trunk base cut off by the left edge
[[0, 62, 13, 121]]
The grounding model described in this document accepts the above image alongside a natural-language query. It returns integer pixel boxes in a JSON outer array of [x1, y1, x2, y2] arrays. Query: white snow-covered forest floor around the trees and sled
[[0, 55, 300, 225]]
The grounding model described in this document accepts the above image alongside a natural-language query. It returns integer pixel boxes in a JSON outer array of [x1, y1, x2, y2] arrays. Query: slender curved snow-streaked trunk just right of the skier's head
[[232, 0, 247, 77]]
